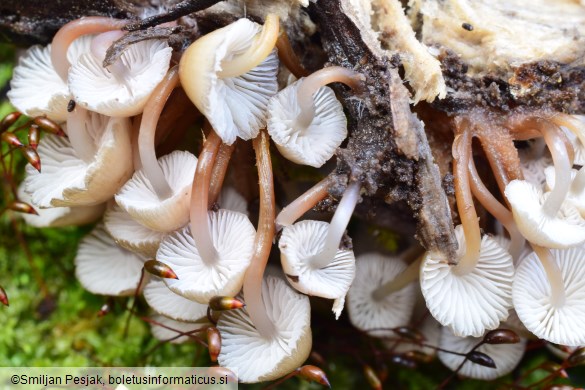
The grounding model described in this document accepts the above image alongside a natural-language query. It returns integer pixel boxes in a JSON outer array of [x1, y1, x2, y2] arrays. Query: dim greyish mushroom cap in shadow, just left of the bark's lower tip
[[347, 253, 417, 337]]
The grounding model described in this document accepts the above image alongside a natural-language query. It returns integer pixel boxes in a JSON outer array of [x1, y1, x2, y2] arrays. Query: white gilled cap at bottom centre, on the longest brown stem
[[217, 276, 312, 383]]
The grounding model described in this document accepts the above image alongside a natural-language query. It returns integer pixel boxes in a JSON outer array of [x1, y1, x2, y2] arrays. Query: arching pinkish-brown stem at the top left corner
[[51, 16, 128, 81]]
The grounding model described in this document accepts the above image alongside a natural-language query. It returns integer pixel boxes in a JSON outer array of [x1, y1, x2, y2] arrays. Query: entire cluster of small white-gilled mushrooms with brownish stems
[[3, 0, 585, 383]]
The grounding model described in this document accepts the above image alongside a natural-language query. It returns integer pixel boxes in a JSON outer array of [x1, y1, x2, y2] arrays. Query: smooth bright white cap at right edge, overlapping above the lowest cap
[[505, 180, 585, 249]]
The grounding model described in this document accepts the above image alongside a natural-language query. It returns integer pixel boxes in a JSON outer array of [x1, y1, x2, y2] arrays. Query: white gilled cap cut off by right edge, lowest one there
[[513, 247, 585, 346]]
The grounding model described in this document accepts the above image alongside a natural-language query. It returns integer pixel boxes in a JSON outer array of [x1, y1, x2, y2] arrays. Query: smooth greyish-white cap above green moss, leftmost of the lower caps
[[75, 226, 144, 295]]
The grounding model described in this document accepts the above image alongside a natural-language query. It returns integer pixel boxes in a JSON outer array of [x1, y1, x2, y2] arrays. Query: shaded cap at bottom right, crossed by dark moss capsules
[[438, 328, 526, 380]]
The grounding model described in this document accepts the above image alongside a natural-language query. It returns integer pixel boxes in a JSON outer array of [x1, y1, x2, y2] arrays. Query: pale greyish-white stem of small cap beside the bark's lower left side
[[308, 182, 361, 269]]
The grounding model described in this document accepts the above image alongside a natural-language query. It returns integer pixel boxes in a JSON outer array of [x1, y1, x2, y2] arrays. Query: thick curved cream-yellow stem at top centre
[[218, 14, 280, 78]]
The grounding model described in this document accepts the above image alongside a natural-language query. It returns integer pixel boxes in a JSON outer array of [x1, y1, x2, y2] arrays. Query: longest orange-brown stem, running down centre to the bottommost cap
[[244, 130, 276, 338]]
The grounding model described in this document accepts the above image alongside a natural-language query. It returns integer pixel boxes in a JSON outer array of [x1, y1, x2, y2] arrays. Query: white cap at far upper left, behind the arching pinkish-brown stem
[[7, 36, 91, 122]]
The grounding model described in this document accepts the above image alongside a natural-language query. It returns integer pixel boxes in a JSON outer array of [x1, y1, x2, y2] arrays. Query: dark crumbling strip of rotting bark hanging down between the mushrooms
[[310, 0, 457, 261]]
